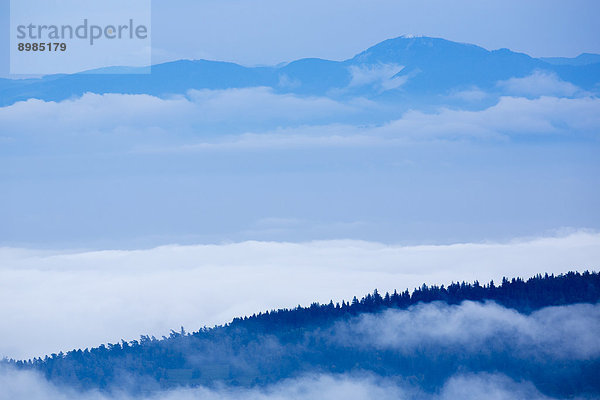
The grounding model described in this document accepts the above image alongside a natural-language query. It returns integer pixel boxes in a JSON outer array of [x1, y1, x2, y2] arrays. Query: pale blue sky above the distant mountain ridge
[[0, 0, 600, 75]]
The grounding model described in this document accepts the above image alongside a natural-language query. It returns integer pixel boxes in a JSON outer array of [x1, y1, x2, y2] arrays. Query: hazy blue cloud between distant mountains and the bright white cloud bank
[[0, 87, 600, 247]]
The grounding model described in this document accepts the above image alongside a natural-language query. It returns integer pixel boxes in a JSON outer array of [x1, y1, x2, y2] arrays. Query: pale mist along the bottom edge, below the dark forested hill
[[0, 370, 568, 400]]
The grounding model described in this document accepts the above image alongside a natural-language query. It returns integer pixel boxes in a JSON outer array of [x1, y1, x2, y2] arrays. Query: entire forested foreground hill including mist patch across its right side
[[6, 272, 600, 396]]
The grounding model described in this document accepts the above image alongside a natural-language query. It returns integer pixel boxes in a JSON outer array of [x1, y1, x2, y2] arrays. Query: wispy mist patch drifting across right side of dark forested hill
[[332, 301, 600, 360]]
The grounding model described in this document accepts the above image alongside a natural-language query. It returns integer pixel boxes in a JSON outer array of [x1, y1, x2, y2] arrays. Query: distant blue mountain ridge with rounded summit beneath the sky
[[0, 37, 600, 106]]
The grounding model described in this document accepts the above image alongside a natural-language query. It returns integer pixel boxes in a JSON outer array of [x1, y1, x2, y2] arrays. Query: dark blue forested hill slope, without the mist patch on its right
[[7, 272, 600, 396]]
